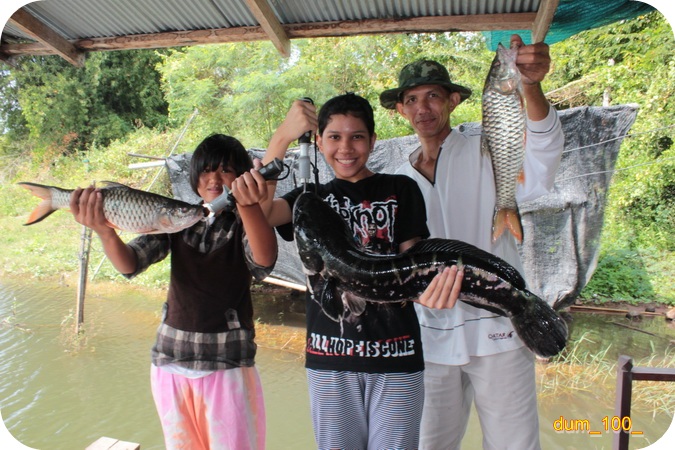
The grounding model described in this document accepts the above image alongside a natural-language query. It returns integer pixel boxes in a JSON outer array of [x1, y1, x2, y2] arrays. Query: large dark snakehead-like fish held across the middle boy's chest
[[293, 192, 567, 357]]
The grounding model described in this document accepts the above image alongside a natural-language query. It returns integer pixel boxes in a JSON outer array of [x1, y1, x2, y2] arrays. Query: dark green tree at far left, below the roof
[[0, 51, 167, 156]]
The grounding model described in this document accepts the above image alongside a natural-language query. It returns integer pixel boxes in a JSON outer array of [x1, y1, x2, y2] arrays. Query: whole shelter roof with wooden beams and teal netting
[[0, 0, 654, 65]]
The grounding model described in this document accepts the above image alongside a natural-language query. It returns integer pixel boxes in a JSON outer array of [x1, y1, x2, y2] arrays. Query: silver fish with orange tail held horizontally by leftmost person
[[18, 182, 205, 234]]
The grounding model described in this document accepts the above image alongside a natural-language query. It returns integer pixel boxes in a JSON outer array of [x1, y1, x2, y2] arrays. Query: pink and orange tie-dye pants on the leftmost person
[[150, 365, 265, 450]]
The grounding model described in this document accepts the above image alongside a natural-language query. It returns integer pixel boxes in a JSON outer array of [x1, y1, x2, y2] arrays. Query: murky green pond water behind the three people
[[0, 280, 675, 450]]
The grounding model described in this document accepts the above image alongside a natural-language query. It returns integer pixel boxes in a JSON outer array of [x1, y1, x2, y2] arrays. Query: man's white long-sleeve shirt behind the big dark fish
[[398, 108, 564, 365]]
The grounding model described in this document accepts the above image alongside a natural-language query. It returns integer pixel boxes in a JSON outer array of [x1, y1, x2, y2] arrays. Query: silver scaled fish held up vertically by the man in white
[[481, 44, 525, 242]]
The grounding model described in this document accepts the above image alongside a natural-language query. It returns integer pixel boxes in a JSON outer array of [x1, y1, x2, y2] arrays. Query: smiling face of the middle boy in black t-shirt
[[316, 114, 377, 183]]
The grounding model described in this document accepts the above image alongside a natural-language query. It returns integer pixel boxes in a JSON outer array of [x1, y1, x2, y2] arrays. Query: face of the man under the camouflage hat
[[396, 84, 461, 140]]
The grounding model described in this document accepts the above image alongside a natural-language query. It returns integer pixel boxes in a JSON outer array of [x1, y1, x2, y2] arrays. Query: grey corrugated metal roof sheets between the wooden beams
[[3, 0, 540, 41]]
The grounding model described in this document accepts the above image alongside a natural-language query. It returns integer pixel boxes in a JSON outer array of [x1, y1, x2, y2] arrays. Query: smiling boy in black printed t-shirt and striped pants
[[251, 94, 461, 449]]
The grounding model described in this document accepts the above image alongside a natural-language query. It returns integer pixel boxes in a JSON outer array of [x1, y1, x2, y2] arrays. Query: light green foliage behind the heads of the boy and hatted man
[[159, 33, 491, 147]]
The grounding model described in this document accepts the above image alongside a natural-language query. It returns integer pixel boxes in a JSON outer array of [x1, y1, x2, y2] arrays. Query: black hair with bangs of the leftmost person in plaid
[[190, 134, 253, 194]]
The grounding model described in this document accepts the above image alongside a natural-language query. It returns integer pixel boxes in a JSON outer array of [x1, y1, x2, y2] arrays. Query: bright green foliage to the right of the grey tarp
[[549, 12, 675, 298]]
